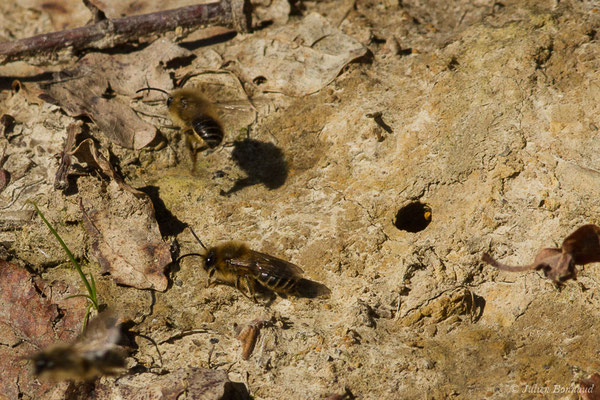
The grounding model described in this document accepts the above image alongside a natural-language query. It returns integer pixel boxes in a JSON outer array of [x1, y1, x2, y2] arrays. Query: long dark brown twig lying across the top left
[[0, 0, 250, 65]]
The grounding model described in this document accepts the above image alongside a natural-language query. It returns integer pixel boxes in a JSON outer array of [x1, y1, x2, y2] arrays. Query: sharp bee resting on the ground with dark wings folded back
[[179, 230, 322, 302]]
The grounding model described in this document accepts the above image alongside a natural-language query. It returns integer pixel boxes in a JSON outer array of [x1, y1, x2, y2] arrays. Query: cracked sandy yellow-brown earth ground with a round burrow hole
[[0, 0, 600, 399]]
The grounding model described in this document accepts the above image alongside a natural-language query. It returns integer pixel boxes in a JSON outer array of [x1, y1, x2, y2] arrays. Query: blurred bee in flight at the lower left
[[30, 314, 127, 381]]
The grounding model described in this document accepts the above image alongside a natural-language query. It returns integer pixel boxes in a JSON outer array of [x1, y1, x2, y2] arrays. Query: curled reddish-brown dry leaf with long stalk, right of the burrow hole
[[482, 224, 600, 284]]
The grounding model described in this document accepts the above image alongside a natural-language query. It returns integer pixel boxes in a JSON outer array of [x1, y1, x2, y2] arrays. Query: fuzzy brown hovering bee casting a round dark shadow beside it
[[136, 87, 224, 155]]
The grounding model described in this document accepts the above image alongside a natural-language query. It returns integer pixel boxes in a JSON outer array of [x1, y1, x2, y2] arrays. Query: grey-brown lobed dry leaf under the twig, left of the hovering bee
[[41, 40, 192, 149]]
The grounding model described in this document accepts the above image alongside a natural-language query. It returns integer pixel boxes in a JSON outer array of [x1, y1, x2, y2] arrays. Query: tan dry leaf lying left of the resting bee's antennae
[[81, 182, 171, 291]]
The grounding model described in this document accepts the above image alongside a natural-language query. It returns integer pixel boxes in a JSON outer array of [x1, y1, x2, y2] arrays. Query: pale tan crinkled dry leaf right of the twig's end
[[224, 13, 367, 96]]
